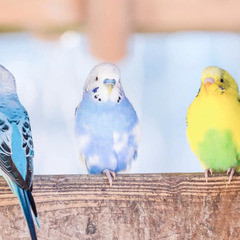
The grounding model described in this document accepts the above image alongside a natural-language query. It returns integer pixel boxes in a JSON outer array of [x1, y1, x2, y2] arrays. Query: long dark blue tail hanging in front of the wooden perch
[[16, 187, 39, 240]]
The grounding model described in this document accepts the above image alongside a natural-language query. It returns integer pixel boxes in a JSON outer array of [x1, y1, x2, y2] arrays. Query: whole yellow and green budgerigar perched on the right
[[186, 66, 240, 183]]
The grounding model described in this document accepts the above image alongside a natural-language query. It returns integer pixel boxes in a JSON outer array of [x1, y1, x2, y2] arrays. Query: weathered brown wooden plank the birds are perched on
[[0, 173, 240, 240]]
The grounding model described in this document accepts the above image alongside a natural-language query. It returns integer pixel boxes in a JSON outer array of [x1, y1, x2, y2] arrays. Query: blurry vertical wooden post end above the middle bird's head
[[86, 0, 132, 61]]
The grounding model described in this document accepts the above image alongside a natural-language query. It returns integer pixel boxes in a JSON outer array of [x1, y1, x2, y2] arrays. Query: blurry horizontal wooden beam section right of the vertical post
[[133, 0, 240, 32]]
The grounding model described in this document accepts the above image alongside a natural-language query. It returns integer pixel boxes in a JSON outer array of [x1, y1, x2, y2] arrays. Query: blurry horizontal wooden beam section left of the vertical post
[[0, 0, 84, 31]]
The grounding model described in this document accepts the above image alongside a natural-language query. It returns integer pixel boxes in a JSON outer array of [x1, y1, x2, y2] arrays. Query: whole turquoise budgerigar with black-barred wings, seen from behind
[[0, 65, 40, 240]]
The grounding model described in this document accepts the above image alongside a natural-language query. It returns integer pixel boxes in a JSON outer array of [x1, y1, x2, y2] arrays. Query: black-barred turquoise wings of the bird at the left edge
[[0, 111, 34, 190]]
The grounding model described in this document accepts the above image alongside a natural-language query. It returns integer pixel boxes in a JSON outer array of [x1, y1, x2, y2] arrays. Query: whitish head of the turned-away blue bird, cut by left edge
[[0, 65, 16, 94]]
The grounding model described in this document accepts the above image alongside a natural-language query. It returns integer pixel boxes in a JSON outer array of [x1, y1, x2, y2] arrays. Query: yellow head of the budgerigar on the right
[[201, 67, 239, 95]]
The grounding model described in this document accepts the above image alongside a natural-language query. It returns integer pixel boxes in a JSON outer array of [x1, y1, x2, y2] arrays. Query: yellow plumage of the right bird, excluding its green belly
[[187, 67, 240, 169]]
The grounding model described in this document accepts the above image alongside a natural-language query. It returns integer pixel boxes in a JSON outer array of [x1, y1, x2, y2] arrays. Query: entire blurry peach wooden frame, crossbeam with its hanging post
[[0, 0, 240, 61]]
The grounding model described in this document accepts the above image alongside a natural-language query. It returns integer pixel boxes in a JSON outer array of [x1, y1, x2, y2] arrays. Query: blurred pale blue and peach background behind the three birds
[[0, 0, 240, 174]]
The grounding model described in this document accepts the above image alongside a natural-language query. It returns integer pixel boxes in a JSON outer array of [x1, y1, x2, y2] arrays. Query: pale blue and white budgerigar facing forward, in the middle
[[75, 63, 140, 186]]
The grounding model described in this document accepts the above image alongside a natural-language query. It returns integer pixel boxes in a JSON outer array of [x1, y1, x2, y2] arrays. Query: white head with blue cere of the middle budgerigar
[[84, 63, 123, 102]]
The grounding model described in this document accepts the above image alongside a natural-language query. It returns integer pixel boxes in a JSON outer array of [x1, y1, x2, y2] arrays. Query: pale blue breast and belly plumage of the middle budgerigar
[[75, 93, 138, 174]]
